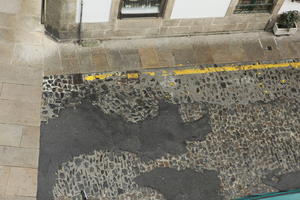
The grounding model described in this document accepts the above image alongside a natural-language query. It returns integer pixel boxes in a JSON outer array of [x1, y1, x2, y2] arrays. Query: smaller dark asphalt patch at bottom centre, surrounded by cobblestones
[[135, 168, 223, 200]]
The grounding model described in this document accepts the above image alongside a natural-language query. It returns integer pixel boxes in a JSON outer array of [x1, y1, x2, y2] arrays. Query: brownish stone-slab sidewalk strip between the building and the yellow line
[[45, 29, 300, 75]]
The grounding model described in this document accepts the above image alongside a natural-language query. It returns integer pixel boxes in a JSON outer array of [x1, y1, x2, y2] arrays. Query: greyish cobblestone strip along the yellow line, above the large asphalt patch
[[42, 65, 300, 123]]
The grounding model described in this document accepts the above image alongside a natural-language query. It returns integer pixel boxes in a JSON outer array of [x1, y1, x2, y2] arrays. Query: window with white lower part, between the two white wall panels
[[119, 0, 166, 18]]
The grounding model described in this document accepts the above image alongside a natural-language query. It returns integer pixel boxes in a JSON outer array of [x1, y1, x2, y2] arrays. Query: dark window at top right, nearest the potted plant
[[234, 0, 274, 14]]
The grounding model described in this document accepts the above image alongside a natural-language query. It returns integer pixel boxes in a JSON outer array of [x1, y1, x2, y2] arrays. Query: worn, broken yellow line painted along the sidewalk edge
[[85, 62, 300, 81]]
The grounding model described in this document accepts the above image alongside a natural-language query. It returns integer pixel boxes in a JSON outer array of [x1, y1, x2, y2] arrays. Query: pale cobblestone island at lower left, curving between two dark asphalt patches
[[53, 151, 162, 200]]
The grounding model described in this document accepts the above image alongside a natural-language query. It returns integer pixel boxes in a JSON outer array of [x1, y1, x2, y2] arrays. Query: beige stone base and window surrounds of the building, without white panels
[[45, 0, 284, 41]]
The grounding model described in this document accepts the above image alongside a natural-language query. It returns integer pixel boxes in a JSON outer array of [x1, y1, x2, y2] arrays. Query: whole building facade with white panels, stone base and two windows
[[42, 0, 300, 41]]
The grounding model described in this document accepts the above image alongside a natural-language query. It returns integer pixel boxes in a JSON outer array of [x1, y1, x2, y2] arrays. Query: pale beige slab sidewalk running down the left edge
[[0, 0, 44, 200]]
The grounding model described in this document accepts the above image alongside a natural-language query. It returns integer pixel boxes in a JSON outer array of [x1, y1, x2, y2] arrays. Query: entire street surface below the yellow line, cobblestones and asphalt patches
[[39, 65, 300, 200]]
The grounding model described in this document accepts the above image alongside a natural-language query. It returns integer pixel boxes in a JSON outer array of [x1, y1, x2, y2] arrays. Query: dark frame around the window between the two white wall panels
[[118, 0, 168, 19]]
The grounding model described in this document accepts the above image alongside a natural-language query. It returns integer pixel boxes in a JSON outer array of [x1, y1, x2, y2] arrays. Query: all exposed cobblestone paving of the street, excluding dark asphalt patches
[[41, 68, 300, 200]]
